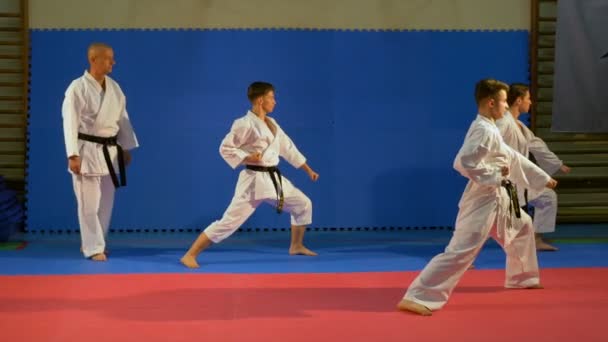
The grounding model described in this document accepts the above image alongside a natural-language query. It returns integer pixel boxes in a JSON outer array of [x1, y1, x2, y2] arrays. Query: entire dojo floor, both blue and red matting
[[0, 225, 608, 342]]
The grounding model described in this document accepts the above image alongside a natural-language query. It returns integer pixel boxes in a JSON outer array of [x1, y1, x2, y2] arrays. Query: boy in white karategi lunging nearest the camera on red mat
[[397, 79, 557, 316]]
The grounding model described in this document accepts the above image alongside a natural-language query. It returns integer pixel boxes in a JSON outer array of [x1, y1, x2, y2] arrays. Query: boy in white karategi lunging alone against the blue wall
[[181, 82, 319, 268]]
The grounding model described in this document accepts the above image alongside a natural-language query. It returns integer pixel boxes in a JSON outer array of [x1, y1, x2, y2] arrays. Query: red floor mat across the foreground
[[0, 268, 608, 342]]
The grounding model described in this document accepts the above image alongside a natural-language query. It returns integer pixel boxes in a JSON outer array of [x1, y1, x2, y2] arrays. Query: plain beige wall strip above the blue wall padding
[[30, 0, 530, 30]]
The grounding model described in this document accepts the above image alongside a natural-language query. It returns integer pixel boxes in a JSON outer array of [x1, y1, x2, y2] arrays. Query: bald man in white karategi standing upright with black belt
[[62, 43, 139, 261]]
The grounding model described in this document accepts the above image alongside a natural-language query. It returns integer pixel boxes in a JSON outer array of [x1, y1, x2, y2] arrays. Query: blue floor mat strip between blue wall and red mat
[[0, 229, 608, 275]]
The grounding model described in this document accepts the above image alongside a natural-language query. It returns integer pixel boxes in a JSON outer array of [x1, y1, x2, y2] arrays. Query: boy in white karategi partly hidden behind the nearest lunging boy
[[496, 83, 570, 251]]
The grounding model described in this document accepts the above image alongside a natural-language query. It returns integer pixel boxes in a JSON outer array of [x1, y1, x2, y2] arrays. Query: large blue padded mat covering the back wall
[[28, 30, 528, 230]]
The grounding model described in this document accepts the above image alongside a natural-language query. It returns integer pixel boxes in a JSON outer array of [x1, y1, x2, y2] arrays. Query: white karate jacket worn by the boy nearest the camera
[[454, 115, 551, 246]]
